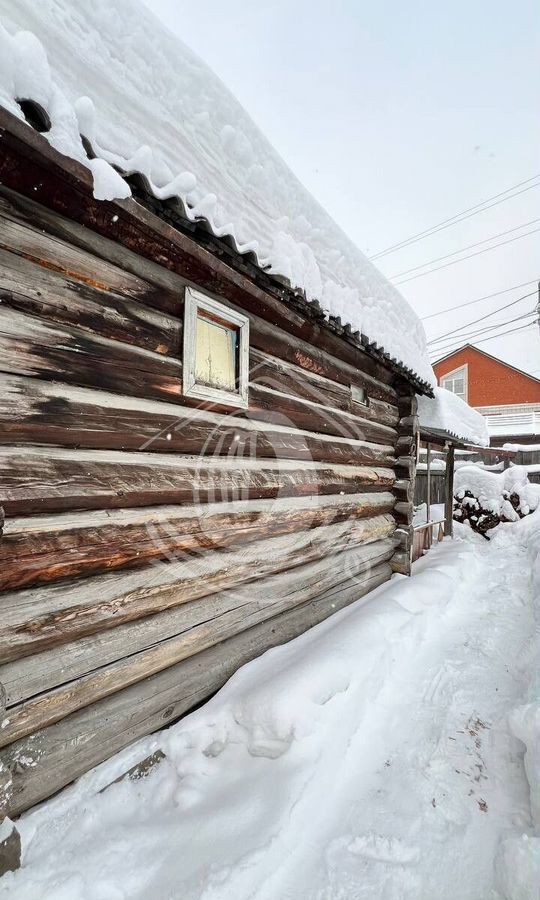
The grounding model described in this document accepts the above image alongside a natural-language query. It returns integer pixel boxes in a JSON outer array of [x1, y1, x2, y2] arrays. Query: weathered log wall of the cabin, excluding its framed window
[[0, 142, 417, 815]]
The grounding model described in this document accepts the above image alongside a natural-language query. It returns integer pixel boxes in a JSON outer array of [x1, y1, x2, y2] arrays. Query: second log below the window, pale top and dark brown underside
[[0, 446, 395, 516]]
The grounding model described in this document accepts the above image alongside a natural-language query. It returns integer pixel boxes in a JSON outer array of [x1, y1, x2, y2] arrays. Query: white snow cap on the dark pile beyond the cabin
[[454, 463, 540, 522]]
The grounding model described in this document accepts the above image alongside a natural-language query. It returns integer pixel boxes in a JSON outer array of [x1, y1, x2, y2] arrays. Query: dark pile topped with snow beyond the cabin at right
[[454, 464, 540, 540]]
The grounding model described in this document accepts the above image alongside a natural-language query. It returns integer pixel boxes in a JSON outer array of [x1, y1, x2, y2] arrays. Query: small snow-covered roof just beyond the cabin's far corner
[[418, 387, 489, 447]]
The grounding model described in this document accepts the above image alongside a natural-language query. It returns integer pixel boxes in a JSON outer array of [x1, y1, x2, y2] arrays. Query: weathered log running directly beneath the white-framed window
[[0, 374, 396, 451]]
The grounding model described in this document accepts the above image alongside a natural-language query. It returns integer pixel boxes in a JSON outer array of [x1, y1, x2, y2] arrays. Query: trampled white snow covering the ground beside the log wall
[[0, 517, 536, 900]]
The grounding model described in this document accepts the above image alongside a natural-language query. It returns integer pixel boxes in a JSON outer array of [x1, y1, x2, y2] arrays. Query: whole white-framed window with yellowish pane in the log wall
[[184, 288, 249, 407]]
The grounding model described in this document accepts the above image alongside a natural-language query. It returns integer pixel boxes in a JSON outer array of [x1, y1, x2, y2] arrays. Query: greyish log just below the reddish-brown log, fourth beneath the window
[[0, 514, 395, 664]]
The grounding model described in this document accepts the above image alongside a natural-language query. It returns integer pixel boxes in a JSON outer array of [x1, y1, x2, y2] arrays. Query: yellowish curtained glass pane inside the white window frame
[[195, 315, 238, 391]]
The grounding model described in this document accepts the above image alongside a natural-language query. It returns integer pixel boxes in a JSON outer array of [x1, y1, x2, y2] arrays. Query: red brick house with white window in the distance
[[433, 344, 540, 446]]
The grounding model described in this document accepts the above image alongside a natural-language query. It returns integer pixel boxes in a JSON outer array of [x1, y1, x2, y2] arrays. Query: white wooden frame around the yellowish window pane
[[183, 287, 249, 409]]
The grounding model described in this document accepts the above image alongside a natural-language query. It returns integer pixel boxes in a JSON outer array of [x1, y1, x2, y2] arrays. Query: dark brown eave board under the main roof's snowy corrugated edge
[[0, 107, 433, 396]]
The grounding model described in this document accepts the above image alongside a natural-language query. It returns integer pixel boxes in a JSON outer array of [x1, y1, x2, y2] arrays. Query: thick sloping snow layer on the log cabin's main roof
[[0, 0, 435, 385]]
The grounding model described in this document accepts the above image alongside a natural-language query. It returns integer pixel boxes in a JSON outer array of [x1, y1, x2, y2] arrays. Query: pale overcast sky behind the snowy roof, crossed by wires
[[145, 0, 540, 375]]
